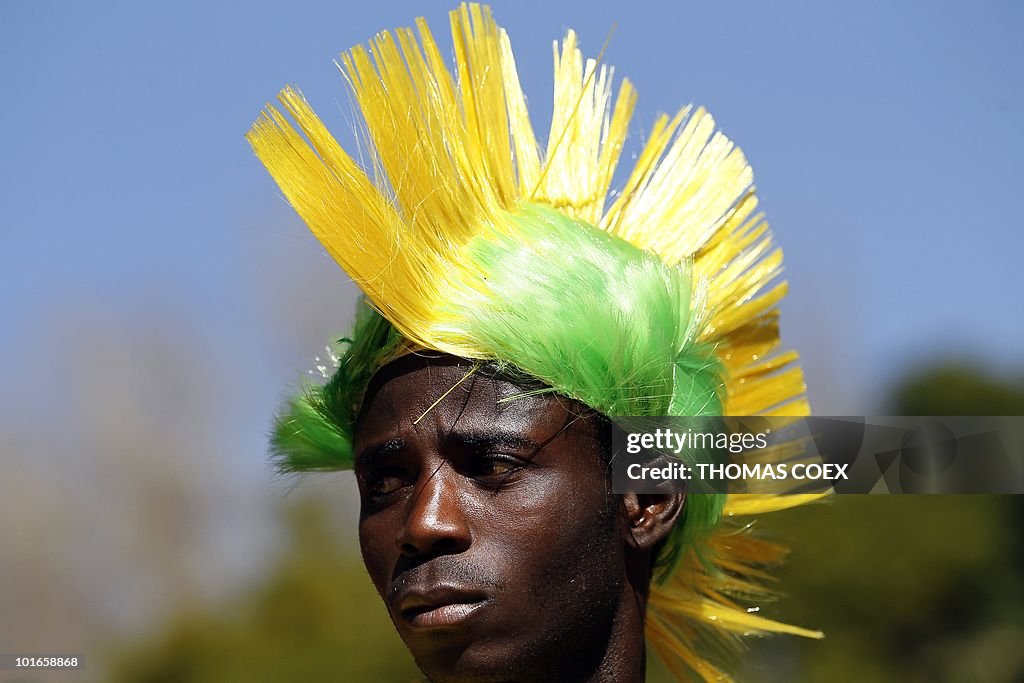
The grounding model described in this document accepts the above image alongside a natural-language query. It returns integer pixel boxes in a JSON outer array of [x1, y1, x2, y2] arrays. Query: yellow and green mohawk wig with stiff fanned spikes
[[248, 4, 820, 680]]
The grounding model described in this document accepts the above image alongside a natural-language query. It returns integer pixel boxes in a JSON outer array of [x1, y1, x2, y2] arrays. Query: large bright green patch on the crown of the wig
[[460, 205, 722, 416]]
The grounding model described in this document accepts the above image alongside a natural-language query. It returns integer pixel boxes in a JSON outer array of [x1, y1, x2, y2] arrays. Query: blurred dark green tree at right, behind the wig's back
[[743, 364, 1024, 683]]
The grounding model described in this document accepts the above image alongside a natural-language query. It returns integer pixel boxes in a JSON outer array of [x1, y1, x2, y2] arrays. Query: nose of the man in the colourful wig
[[397, 465, 472, 557]]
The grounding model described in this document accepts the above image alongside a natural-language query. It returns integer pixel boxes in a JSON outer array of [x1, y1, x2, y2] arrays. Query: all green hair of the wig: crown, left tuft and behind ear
[[271, 205, 724, 579]]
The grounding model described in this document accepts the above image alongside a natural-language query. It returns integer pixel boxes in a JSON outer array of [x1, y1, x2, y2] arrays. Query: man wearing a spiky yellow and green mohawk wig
[[249, 5, 819, 681]]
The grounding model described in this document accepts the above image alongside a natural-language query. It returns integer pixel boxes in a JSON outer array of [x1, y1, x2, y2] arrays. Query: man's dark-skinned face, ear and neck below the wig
[[355, 354, 684, 683]]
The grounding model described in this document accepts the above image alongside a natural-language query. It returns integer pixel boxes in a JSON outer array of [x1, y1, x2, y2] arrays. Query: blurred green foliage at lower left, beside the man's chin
[[109, 498, 423, 683]]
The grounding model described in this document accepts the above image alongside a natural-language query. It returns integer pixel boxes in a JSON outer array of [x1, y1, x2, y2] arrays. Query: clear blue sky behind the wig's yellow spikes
[[0, 0, 1024, 417]]
